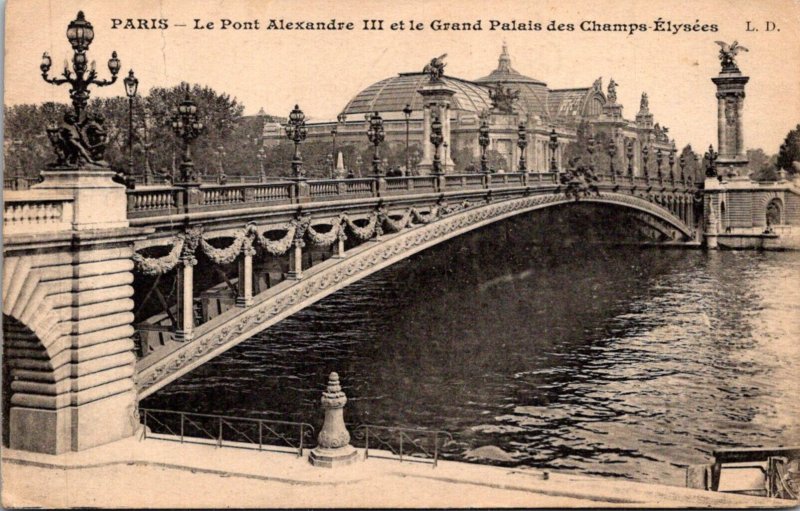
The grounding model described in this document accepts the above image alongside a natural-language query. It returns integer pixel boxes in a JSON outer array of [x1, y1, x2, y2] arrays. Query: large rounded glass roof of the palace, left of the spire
[[344, 73, 492, 115]]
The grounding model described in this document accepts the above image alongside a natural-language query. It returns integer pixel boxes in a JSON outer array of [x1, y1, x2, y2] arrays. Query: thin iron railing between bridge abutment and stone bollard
[[139, 408, 314, 456]]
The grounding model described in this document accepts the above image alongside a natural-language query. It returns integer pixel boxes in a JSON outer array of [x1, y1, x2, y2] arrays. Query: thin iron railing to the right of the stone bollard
[[353, 424, 453, 467]]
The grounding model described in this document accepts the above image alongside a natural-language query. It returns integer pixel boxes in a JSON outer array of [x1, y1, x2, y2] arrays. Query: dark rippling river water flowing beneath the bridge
[[143, 208, 800, 485]]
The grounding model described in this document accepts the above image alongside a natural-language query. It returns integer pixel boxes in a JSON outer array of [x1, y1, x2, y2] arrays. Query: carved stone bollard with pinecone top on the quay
[[308, 372, 358, 468]]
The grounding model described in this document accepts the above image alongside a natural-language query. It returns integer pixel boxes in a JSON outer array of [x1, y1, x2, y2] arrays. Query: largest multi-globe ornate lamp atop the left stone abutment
[[39, 11, 120, 123]]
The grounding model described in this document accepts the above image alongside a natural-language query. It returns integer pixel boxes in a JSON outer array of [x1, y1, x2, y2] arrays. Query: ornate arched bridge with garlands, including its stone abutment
[[3, 171, 699, 453]]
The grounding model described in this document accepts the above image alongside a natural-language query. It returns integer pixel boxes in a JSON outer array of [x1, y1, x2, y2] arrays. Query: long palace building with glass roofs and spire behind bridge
[[264, 45, 677, 177]]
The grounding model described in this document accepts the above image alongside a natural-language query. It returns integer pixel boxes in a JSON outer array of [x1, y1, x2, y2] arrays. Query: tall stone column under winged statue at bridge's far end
[[711, 53, 750, 179]]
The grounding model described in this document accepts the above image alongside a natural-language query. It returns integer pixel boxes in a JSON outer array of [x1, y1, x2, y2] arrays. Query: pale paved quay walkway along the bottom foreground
[[2, 439, 797, 508]]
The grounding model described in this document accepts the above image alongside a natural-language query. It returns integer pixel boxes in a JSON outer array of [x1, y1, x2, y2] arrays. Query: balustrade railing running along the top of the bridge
[[128, 172, 693, 219]]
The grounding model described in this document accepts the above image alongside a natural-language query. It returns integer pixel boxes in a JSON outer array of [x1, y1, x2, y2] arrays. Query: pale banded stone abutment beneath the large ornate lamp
[[3, 170, 143, 454]]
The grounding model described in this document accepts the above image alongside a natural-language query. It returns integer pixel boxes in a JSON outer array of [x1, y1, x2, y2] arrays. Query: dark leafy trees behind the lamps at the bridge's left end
[[4, 82, 282, 182]]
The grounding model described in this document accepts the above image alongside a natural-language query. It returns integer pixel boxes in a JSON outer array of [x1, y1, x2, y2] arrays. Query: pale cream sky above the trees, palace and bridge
[[5, 0, 800, 153]]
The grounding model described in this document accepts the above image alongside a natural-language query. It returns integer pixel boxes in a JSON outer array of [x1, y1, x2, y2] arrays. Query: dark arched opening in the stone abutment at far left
[[2, 314, 48, 447]]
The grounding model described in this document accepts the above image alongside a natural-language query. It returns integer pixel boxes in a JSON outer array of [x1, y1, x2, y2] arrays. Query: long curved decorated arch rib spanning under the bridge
[[137, 192, 692, 400]]
